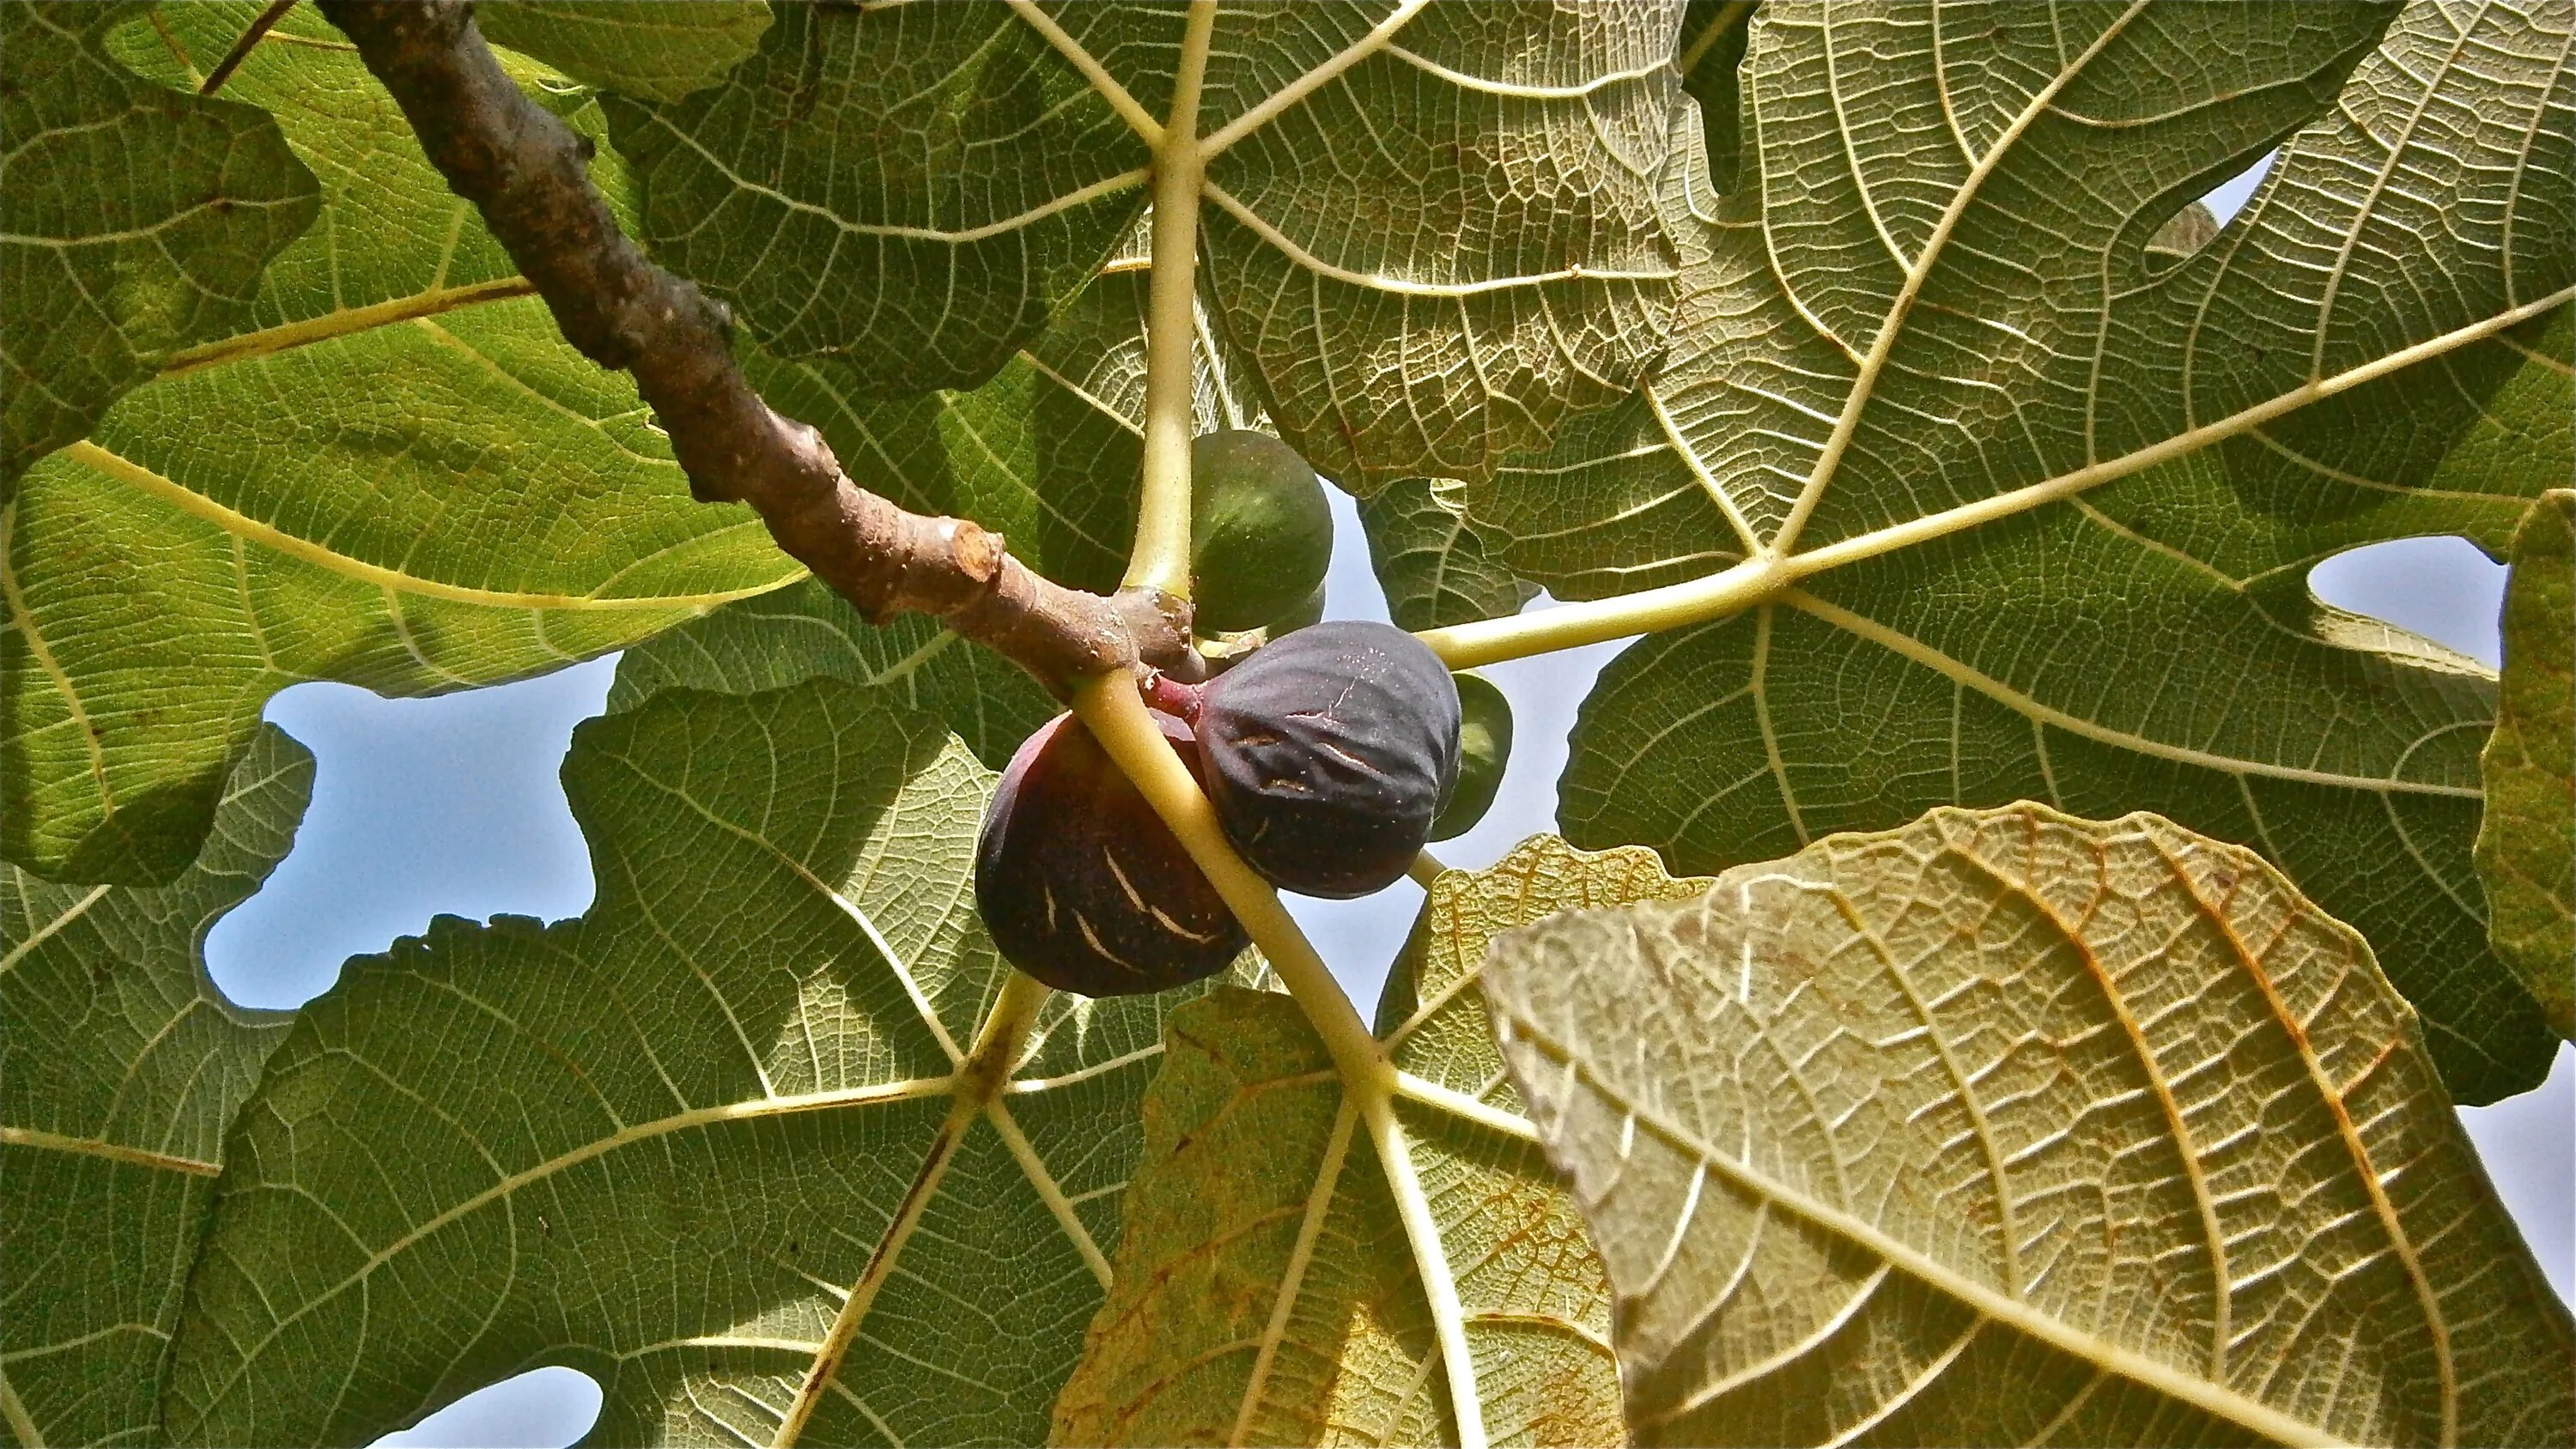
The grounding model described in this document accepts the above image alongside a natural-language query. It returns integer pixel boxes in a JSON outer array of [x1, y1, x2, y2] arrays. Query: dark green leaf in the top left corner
[[0, 3, 317, 494]]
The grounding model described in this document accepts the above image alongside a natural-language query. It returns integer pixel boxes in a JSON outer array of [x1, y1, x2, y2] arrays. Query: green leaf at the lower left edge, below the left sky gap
[[0, 728, 314, 1444]]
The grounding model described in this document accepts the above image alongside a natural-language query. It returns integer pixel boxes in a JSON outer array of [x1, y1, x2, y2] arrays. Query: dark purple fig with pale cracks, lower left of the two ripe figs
[[974, 716, 1249, 996]]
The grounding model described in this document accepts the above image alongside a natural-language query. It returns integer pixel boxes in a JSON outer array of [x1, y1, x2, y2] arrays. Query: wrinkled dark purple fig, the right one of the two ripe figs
[[1193, 621, 1458, 898]]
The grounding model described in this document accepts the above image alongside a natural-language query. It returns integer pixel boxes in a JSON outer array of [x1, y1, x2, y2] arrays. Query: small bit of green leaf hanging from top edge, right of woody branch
[[474, 0, 770, 100]]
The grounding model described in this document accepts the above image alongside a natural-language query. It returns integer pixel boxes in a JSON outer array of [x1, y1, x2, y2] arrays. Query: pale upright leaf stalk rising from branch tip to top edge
[[1123, 0, 1216, 600]]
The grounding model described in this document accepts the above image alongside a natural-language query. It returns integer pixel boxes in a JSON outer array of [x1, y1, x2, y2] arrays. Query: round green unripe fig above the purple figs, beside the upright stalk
[[1190, 430, 1332, 634]]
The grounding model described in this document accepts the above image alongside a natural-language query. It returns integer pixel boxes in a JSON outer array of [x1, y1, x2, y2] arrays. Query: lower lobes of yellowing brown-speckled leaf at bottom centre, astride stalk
[[1054, 991, 1620, 1444]]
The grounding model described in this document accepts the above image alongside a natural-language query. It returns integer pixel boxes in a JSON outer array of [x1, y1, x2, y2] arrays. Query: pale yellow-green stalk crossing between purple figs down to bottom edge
[[1074, 675, 1486, 1449]]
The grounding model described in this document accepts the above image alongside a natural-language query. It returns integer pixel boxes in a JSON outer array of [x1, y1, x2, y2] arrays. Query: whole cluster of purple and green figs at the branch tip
[[974, 433, 1512, 996]]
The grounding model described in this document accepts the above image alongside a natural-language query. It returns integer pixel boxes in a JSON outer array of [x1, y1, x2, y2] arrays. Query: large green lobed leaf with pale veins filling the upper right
[[1535, 0, 2576, 1101]]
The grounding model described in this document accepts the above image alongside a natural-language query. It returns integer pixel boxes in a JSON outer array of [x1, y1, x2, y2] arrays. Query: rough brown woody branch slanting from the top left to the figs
[[322, 0, 1193, 698]]
